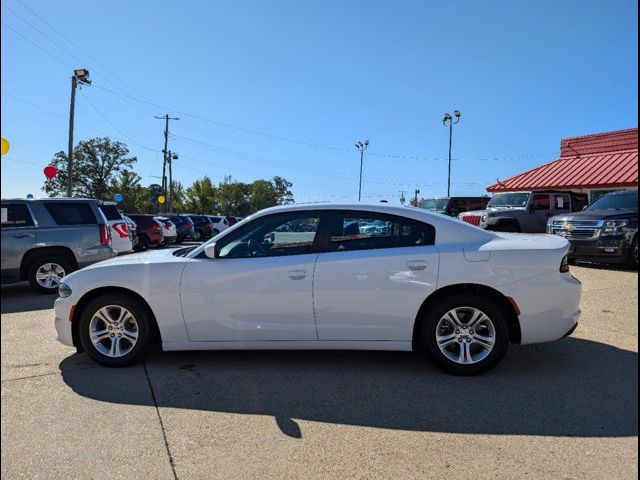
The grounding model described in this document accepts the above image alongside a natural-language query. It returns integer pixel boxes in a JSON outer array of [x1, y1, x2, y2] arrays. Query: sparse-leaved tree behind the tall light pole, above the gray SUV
[[43, 137, 137, 200]]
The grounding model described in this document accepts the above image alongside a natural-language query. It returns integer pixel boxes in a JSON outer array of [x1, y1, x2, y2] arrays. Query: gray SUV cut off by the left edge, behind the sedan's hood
[[2, 198, 115, 293]]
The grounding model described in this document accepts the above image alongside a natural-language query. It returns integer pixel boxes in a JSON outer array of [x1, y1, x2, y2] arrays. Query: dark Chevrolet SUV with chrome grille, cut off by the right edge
[[547, 190, 638, 269]]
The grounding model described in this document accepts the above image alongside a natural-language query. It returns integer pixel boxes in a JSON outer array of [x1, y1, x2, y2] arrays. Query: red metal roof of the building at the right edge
[[487, 128, 638, 201]]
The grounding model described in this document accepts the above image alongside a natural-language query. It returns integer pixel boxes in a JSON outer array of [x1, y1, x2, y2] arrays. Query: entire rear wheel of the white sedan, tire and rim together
[[419, 294, 509, 375]]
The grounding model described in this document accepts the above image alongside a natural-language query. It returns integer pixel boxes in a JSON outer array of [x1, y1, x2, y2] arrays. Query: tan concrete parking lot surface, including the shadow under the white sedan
[[1, 267, 638, 479]]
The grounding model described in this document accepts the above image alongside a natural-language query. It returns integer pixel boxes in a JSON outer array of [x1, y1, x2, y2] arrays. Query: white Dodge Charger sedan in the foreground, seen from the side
[[55, 204, 581, 375]]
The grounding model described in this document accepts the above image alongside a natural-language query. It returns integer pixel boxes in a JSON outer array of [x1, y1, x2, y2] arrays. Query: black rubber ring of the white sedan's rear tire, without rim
[[420, 294, 509, 375]]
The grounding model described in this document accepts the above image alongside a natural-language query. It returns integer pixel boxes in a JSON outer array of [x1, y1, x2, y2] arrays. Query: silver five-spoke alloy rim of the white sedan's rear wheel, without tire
[[436, 307, 496, 365]]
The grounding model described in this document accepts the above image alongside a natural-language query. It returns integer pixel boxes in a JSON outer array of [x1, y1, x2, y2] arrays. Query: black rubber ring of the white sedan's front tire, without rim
[[78, 293, 152, 367]]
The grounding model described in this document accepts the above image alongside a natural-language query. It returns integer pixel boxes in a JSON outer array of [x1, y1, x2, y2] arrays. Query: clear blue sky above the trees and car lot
[[1, 0, 638, 203]]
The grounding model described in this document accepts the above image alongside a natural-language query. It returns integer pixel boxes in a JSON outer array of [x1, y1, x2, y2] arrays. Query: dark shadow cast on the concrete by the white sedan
[[60, 338, 638, 438]]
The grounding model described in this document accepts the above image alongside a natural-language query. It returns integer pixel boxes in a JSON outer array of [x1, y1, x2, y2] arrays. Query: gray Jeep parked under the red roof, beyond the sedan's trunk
[[458, 190, 589, 233]]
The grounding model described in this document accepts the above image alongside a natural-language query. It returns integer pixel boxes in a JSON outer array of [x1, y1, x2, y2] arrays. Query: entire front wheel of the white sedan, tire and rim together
[[78, 293, 153, 367]]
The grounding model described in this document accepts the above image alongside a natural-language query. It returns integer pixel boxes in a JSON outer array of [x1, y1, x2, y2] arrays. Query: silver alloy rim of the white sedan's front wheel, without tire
[[89, 305, 139, 358]]
